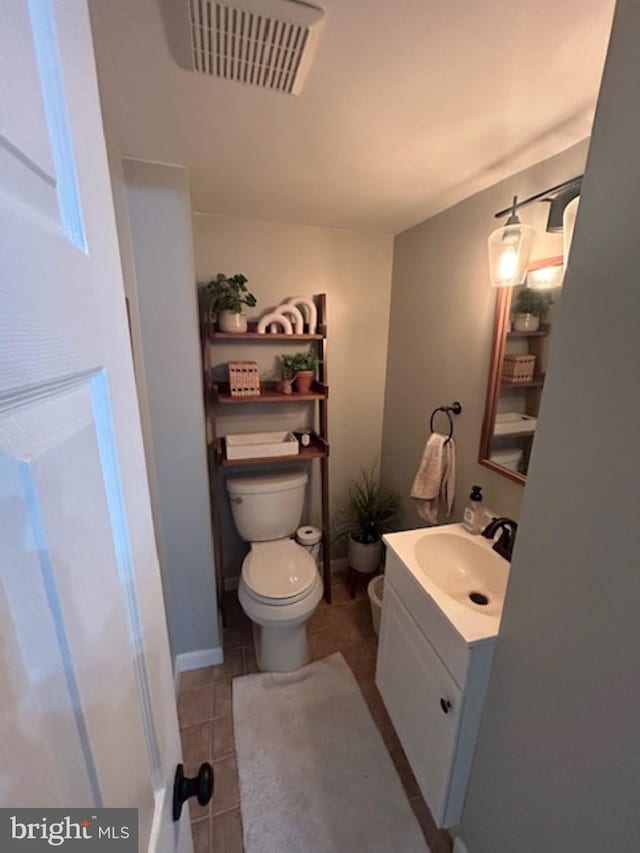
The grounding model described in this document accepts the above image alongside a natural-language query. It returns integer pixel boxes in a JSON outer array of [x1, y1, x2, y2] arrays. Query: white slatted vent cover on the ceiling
[[188, 0, 324, 95]]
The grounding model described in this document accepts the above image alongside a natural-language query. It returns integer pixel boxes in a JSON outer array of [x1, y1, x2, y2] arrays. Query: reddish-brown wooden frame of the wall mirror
[[478, 255, 564, 486]]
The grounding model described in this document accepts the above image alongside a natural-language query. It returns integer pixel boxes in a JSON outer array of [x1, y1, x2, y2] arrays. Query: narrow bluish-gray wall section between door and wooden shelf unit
[[119, 160, 220, 655]]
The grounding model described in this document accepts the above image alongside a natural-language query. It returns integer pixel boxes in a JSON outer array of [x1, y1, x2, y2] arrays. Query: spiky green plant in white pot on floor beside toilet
[[336, 465, 400, 574]]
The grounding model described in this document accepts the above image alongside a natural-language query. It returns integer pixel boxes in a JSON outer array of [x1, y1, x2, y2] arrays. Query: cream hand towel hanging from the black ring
[[411, 432, 456, 524]]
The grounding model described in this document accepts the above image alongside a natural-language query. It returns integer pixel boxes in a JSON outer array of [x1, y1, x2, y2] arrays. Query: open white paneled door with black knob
[[0, 0, 192, 851]]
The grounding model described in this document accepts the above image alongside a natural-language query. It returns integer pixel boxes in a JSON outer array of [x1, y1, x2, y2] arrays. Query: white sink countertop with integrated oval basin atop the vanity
[[384, 524, 510, 643]]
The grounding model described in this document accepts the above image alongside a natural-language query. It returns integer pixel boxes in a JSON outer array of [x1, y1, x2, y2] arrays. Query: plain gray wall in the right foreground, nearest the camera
[[462, 0, 640, 853]]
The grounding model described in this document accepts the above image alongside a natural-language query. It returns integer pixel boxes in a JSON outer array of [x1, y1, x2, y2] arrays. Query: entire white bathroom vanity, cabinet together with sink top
[[376, 524, 509, 827]]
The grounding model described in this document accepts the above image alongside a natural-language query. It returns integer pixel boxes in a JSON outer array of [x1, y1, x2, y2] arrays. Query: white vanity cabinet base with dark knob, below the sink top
[[376, 549, 494, 826]]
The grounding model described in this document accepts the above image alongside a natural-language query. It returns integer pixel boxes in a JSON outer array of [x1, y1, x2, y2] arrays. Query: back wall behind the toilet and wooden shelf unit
[[193, 214, 393, 576]]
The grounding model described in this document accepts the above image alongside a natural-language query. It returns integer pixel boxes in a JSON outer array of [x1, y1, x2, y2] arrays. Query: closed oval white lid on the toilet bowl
[[242, 539, 317, 603]]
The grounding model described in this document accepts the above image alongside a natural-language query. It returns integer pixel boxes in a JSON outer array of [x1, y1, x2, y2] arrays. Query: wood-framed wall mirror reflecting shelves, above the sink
[[479, 255, 564, 483]]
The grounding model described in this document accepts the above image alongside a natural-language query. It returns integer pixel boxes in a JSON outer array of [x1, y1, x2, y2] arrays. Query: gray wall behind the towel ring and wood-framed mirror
[[382, 142, 587, 527]]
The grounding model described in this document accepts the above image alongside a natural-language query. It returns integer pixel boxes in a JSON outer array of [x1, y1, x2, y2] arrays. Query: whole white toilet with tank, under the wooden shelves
[[226, 471, 322, 672]]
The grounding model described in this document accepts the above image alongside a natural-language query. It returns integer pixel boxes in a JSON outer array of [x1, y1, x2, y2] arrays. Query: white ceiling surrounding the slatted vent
[[91, 0, 614, 233]]
